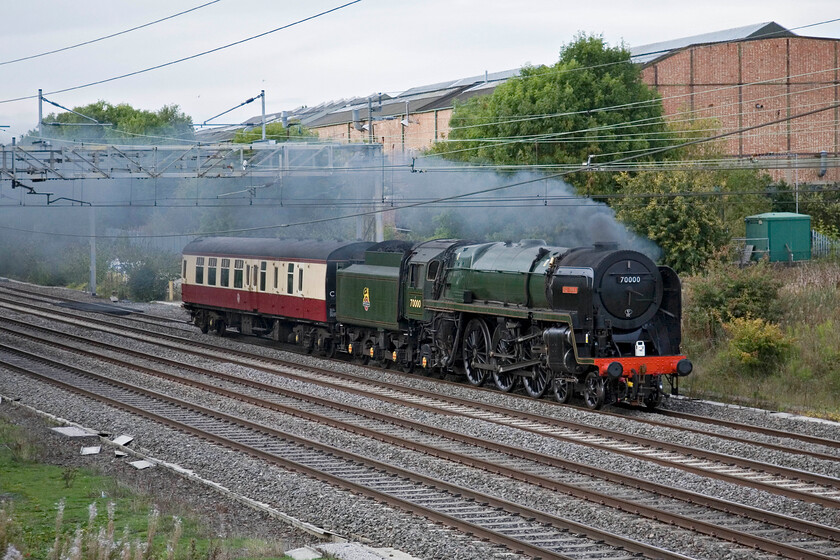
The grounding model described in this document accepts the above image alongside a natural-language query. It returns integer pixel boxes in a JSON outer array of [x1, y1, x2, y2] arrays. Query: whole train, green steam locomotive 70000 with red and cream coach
[[182, 237, 692, 409]]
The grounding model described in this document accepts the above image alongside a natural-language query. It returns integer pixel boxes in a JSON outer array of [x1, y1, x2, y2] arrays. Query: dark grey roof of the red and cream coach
[[183, 237, 373, 261]]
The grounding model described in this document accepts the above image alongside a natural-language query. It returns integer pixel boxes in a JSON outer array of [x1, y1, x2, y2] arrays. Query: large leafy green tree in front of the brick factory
[[432, 34, 664, 193]]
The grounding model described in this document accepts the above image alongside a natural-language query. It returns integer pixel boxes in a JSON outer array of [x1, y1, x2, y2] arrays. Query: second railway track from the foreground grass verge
[[1, 320, 840, 560]]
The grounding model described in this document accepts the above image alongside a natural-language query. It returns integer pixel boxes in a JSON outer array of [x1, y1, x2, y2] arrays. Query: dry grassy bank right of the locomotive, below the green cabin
[[680, 260, 840, 420]]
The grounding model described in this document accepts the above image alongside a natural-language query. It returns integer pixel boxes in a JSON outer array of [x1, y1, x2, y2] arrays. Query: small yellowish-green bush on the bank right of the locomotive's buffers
[[724, 317, 794, 375]]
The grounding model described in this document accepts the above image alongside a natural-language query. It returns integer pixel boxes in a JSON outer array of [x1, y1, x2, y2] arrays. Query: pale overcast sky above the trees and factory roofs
[[0, 0, 840, 140]]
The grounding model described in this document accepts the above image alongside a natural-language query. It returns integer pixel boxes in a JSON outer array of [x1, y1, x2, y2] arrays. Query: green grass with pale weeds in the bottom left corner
[[0, 419, 296, 560]]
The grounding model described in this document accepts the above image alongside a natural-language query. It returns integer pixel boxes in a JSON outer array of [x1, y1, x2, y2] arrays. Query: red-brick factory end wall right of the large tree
[[631, 23, 840, 183]]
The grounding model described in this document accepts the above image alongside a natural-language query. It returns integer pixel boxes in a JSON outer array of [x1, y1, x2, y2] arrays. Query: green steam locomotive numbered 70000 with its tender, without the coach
[[334, 240, 692, 409]]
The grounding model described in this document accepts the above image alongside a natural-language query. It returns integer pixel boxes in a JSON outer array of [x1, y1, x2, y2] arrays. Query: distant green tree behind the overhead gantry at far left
[[28, 101, 195, 144]]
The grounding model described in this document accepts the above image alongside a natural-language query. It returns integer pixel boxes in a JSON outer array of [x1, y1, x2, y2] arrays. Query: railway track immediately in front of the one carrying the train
[[0, 301, 840, 508]]
